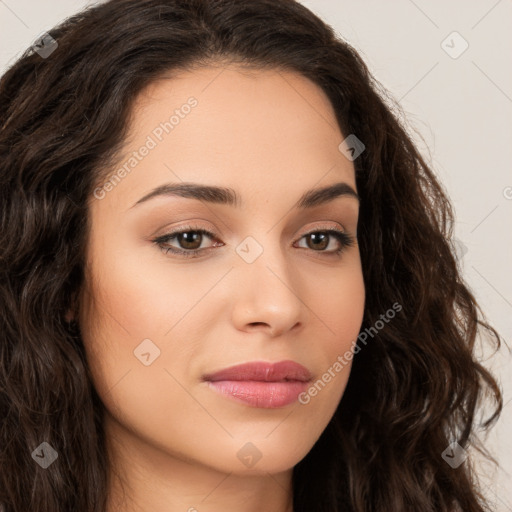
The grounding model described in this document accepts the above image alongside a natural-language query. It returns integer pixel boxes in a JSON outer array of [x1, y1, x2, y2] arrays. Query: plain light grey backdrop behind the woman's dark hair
[[0, 0, 512, 512]]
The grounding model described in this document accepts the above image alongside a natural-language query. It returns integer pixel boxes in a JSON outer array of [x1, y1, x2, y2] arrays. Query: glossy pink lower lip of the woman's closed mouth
[[208, 380, 308, 409]]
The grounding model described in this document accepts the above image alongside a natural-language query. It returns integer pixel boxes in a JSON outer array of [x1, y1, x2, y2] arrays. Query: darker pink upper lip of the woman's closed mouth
[[203, 361, 311, 382]]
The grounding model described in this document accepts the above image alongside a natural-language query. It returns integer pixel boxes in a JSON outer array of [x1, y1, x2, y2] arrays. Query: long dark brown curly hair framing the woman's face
[[0, 0, 502, 512]]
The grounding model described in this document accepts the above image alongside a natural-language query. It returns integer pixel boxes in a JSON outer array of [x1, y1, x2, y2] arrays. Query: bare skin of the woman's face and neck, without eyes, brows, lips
[[79, 65, 365, 512]]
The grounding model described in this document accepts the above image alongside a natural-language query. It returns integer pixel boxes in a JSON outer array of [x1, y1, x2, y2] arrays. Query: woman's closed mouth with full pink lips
[[203, 361, 311, 409]]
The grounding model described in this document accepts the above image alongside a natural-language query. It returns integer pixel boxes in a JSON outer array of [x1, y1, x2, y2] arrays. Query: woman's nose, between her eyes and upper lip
[[232, 242, 307, 337]]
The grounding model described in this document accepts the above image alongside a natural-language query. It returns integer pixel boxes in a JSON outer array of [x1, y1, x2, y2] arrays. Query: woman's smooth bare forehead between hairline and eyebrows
[[94, 64, 355, 212]]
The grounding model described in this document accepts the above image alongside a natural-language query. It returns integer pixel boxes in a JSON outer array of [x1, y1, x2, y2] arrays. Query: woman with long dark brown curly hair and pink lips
[[0, 0, 502, 512]]
